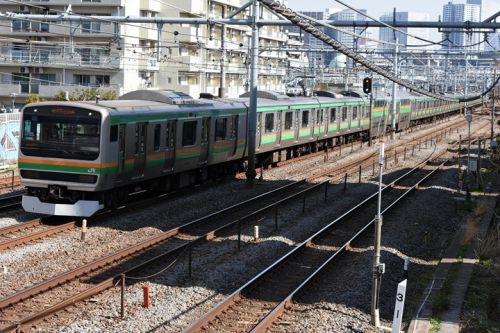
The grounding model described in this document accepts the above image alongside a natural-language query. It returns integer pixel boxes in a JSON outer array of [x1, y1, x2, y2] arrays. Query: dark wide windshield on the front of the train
[[21, 106, 101, 160]]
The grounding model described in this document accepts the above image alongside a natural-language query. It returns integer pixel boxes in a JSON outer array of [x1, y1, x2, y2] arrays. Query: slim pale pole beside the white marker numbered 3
[[371, 137, 385, 326]]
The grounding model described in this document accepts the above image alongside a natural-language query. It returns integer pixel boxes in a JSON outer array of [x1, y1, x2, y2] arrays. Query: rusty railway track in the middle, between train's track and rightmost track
[[0, 115, 484, 332]]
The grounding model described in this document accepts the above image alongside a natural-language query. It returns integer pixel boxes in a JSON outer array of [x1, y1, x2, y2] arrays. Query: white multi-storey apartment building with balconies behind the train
[[0, 0, 307, 111]]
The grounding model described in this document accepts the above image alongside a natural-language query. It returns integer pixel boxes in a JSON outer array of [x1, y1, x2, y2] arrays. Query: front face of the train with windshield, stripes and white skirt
[[19, 102, 109, 216]]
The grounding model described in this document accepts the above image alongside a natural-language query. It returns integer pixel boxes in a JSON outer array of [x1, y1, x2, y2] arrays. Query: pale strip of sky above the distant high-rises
[[288, 0, 500, 20]]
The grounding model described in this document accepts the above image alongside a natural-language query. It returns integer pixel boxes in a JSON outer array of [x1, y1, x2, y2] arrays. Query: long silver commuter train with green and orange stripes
[[18, 90, 480, 217]]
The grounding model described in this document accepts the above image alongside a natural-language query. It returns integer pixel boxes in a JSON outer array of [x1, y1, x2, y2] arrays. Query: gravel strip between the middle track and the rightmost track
[[31, 116, 492, 332]]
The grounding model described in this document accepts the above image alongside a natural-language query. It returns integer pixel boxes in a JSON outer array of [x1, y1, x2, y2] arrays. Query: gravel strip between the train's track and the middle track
[[0, 116, 460, 297]]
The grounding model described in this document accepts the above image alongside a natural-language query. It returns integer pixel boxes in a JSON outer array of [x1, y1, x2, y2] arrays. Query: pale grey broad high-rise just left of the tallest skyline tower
[[379, 12, 430, 49]]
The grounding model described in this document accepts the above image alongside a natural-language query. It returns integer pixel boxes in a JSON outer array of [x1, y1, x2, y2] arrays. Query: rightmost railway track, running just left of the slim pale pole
[[185, 146, 460, 332]]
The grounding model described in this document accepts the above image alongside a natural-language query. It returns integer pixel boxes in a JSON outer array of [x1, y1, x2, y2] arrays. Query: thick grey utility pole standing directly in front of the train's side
[[246, 0, 259, 186]]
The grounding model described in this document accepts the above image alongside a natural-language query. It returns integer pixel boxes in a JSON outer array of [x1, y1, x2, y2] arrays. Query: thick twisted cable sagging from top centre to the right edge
[[259, 0, 500, 102]]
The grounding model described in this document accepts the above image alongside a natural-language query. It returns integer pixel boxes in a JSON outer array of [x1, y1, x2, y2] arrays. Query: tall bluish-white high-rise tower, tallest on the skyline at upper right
[[443, 0, 481, 49]]
